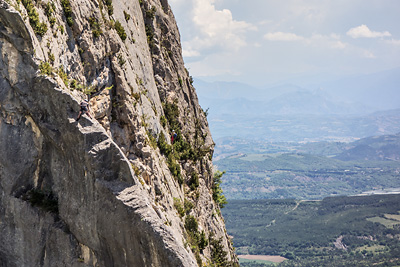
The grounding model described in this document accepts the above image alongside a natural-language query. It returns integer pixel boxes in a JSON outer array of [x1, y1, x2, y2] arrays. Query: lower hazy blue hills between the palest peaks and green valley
[[208, 109, 400, 142]]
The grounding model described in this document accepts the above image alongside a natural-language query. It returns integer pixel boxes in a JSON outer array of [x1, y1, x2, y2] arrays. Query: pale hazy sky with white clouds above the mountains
[[169, 0, 400, 85]]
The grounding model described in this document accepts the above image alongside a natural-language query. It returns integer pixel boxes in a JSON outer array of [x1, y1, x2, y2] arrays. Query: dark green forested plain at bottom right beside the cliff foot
[[223, 195, 400, 266]]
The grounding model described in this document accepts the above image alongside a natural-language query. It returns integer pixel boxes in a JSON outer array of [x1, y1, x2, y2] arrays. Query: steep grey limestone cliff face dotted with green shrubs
[[0, 0, 237, 267]]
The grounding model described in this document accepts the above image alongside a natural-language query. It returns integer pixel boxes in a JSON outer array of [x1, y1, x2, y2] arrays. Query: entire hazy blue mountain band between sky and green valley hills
[[194, 68, 400, 142]]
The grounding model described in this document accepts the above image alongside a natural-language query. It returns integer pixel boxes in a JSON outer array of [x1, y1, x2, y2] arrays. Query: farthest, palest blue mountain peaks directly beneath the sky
[[195, 68, 400, 116]]
